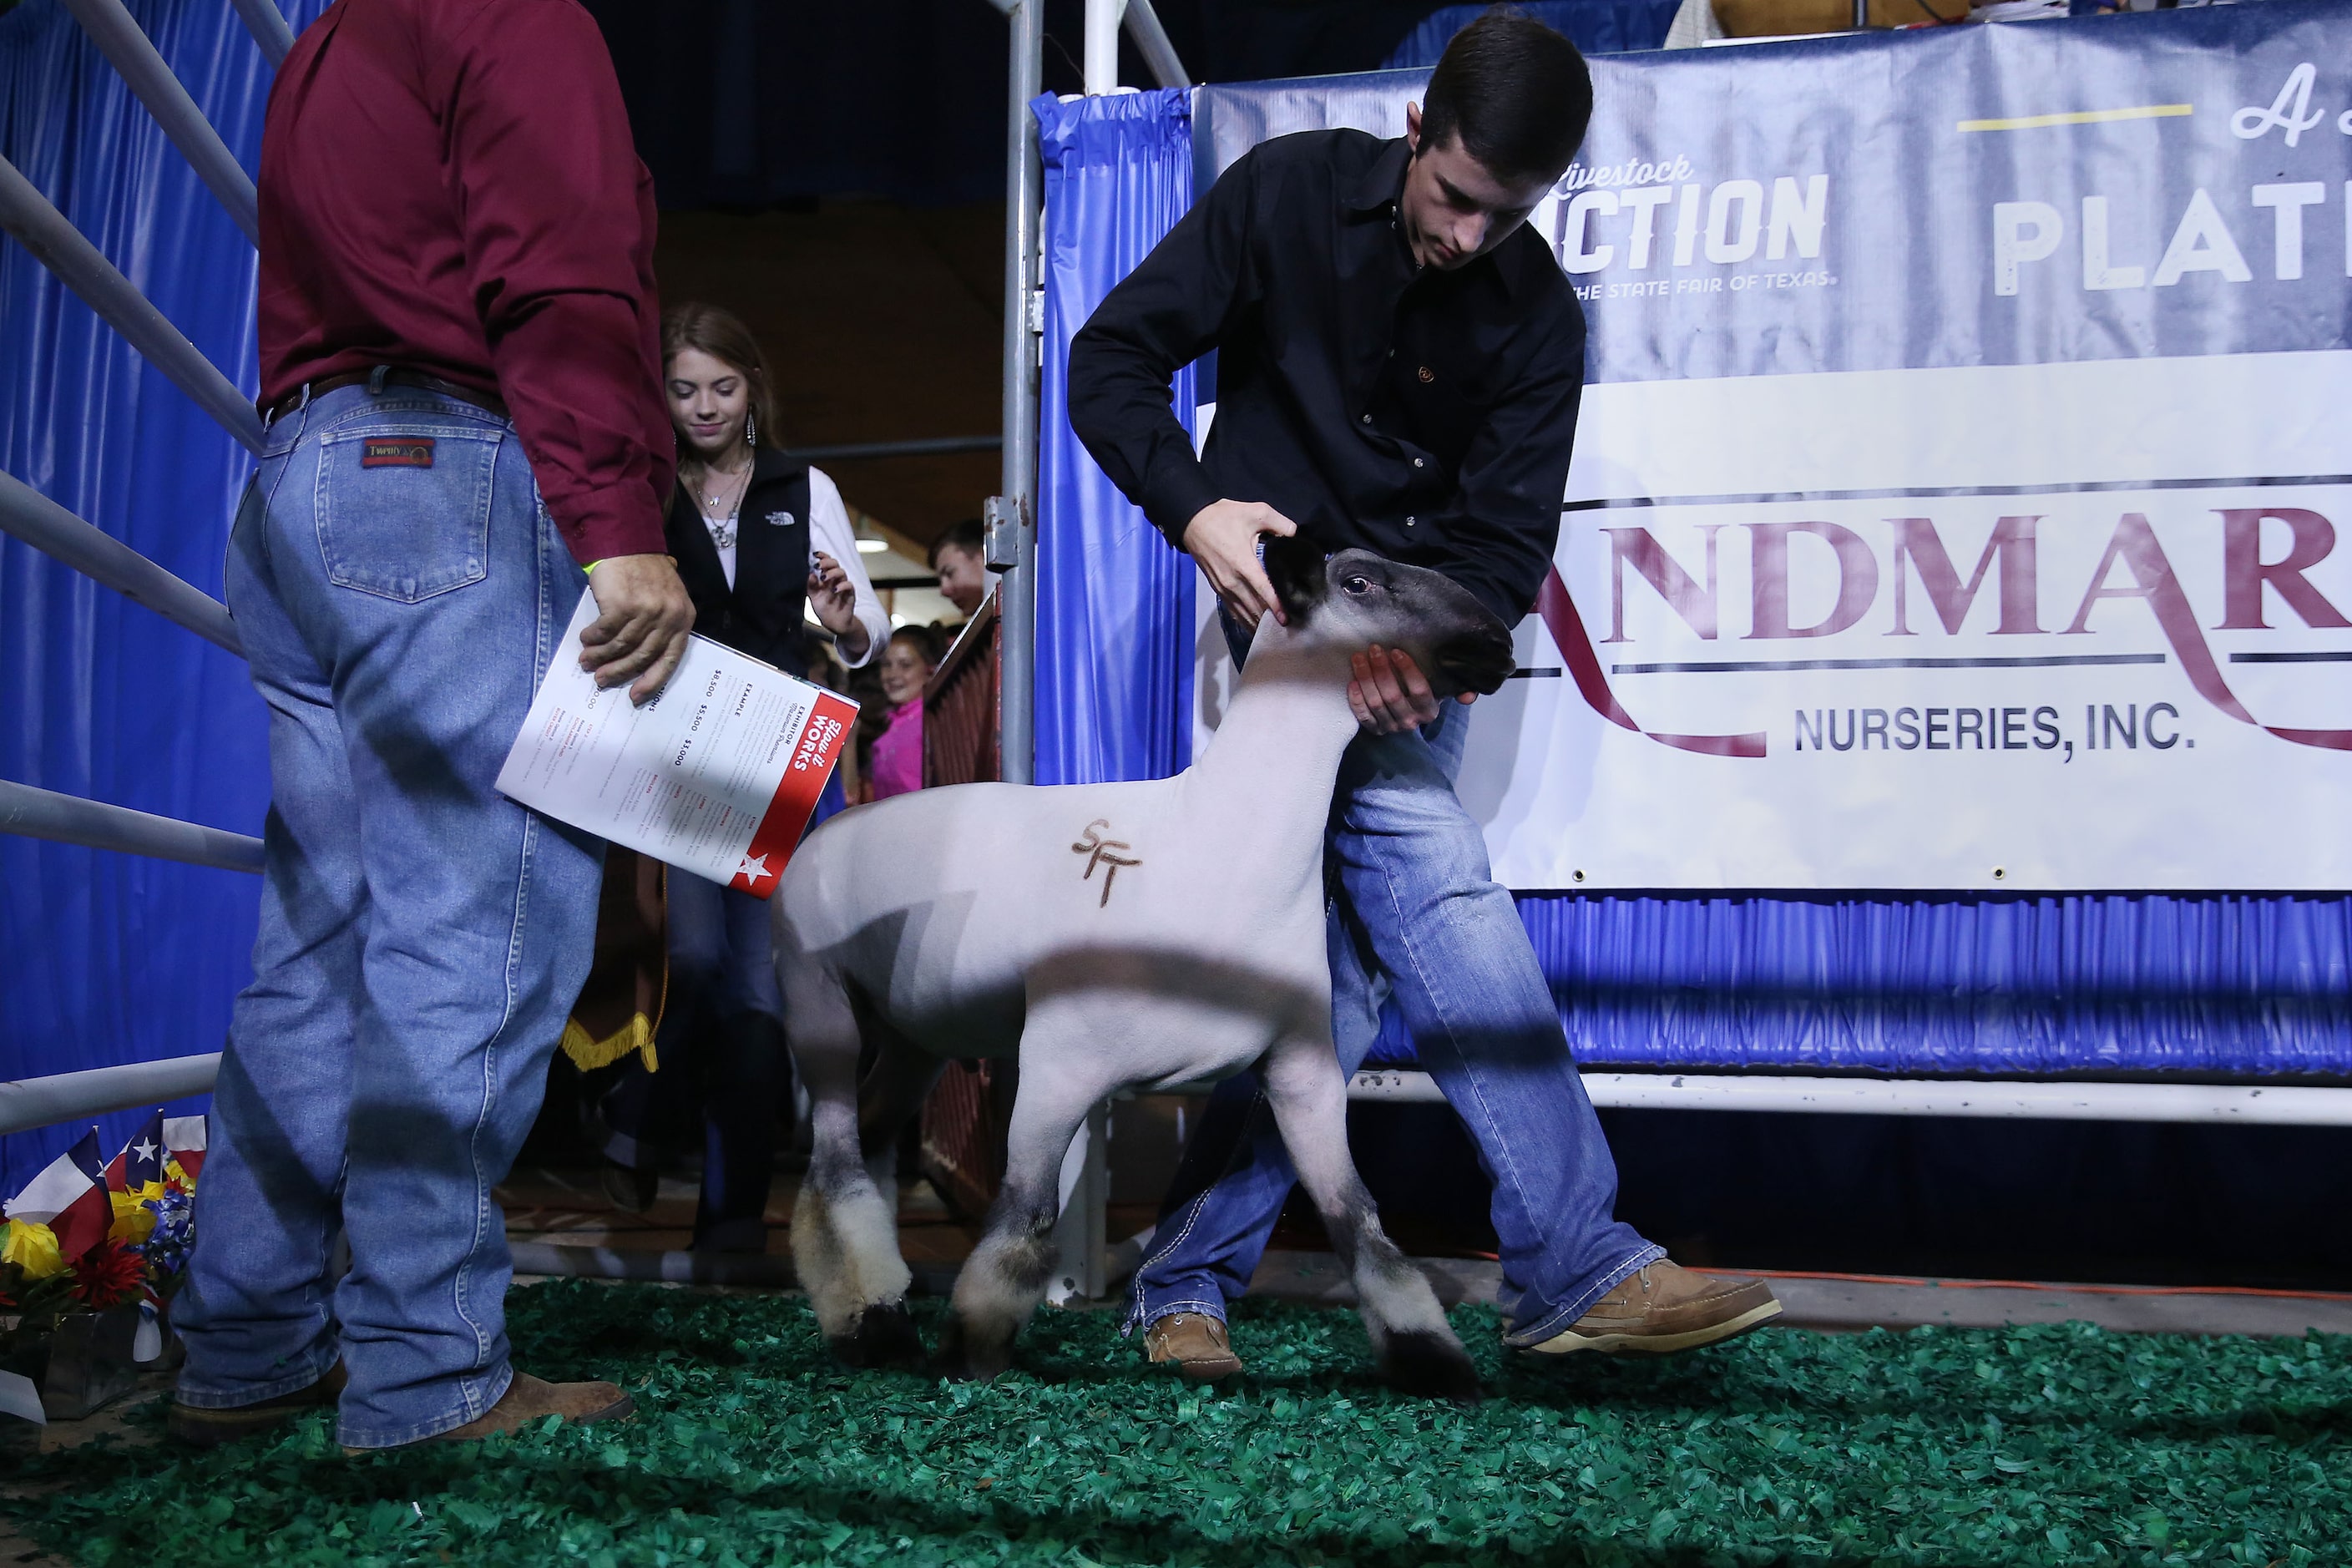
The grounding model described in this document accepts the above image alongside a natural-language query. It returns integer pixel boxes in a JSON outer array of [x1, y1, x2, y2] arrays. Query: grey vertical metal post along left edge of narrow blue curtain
[[988, 0, 1044, 783]]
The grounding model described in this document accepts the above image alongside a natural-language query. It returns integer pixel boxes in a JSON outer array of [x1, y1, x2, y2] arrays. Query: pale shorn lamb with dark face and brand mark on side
[[774, 541, 1512, 1399]]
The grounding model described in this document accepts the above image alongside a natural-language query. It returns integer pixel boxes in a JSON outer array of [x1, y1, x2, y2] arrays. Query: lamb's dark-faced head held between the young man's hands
[[1266, 539, 1515, 698]]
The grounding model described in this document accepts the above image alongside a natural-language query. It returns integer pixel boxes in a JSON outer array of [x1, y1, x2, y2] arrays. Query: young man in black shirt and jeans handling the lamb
[[1070, 9, 1780, 1380]]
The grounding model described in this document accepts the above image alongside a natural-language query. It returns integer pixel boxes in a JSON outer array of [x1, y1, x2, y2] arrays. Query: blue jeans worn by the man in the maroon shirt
[[172, 386, 602, 1448]]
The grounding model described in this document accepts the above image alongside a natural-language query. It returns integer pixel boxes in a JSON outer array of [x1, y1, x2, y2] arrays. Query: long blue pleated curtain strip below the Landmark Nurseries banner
[[1373, 893, 2352, 1079]]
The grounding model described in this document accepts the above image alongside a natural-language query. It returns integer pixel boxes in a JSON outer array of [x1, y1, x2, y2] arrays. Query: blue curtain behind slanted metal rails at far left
[[0, 0, 325, 1192]]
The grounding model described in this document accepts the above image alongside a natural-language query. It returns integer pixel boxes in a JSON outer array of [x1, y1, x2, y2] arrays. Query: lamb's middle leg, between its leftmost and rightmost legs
[[938, 1044, 1100, 1380]]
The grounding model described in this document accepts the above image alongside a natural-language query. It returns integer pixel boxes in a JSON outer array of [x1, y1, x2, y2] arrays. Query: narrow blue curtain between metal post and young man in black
[[1030, 89, 1195, 783]]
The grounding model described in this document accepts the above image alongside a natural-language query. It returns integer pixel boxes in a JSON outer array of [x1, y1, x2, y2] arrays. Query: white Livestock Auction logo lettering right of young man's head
[[1545, 153, 1837, 301]]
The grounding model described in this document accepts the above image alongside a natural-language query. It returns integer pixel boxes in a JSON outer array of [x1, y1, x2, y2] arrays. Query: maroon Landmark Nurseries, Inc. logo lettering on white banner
[[1538, 503, 2352, 764]]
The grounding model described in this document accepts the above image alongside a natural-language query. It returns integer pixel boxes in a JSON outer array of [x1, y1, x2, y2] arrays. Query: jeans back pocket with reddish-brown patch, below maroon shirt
[[317, 416, 506, 604]]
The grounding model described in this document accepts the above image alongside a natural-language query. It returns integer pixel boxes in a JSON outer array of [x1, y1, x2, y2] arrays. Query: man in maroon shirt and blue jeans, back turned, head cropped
[[172, 0, 694, 1448]]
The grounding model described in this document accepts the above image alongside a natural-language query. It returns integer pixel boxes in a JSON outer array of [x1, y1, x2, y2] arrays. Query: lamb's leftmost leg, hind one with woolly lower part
[[776, 959, 922, 1366]]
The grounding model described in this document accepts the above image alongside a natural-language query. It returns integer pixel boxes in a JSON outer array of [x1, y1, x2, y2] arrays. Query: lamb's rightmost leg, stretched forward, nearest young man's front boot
[[1261, 1037, 1479, 1404]]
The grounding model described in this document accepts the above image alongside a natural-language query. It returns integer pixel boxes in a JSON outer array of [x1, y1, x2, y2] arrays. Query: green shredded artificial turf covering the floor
[[7, 1283, 2352, 1568]]
